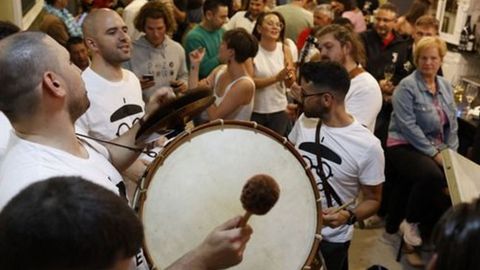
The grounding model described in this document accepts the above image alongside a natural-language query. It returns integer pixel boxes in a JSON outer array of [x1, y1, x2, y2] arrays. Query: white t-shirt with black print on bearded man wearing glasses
[[288, 114, 385, 243]]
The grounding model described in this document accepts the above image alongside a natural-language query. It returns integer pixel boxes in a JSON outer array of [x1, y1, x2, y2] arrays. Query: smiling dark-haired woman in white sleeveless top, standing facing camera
[[252, 11, 295, 135]]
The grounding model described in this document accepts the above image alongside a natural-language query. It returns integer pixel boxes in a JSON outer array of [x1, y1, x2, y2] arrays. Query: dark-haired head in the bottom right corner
[[432, 199, 480, 270]]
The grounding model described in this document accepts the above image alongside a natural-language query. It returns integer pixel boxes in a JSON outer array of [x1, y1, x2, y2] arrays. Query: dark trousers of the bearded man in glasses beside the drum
[[320, 240, 350, 270]]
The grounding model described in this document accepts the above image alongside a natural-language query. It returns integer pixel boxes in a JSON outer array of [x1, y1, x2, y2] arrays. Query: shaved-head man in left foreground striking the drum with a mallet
[[0, 32, 252, 269]]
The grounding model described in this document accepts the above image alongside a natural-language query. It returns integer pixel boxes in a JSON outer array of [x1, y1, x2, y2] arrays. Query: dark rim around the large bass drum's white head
[[138, 119, 322, 269]]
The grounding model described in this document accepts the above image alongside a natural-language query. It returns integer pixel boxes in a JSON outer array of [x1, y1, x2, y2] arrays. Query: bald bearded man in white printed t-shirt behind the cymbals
[[76, 9, 158, 194]]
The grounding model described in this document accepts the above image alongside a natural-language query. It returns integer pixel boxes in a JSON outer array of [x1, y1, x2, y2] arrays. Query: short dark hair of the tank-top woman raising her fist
[[223, 28, 258, 63]]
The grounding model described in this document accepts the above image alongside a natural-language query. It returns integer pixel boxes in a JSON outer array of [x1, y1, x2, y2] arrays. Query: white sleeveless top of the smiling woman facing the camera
[[253, 42, 287, 113]]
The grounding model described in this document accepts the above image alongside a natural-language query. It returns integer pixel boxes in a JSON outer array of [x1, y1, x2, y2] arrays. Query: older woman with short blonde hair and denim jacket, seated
[[386, 37, 458, 246]]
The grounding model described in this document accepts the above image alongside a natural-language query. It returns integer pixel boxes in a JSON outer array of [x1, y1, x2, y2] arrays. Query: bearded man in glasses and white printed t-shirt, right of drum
[[289, 61, 385, 269]]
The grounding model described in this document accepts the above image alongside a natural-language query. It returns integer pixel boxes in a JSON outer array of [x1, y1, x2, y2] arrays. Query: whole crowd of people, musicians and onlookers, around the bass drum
[[0, 0, 479, 270]]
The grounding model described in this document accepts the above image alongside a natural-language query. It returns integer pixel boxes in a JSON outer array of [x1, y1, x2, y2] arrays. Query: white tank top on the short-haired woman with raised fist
[[213, 68, 255, 121]]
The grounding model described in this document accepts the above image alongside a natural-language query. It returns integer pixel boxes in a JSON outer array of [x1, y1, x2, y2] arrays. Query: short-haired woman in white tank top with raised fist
[[188, 28, 258, 121]]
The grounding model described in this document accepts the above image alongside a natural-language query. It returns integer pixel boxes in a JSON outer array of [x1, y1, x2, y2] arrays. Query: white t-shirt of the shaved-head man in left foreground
[[0, 131, 149, 270]]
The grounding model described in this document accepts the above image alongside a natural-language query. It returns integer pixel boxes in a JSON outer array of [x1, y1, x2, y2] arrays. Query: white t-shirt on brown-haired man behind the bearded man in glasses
[[345, 72, 382, 132]]
